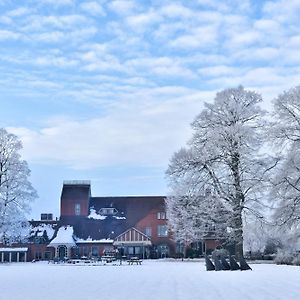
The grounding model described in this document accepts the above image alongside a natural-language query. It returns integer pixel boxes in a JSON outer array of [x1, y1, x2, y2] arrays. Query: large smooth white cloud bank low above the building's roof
[[9, 87, 212, 169]]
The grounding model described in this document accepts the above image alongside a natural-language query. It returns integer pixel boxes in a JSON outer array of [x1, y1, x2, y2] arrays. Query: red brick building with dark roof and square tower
[[0, 181, 215, 262]]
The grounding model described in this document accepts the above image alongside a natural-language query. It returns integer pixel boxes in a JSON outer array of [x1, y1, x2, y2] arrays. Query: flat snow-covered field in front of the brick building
[[0, 260, 300, 300]]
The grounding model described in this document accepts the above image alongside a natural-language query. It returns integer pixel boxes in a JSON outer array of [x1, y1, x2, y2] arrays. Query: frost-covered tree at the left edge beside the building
[[0, 128, 37, 244]]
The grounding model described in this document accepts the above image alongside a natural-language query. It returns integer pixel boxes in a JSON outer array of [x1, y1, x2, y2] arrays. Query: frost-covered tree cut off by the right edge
[[271, 86, 300, 228]]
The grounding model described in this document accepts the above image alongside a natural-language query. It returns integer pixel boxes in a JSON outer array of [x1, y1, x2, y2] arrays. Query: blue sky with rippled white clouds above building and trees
[[0, 0, 300, 219]]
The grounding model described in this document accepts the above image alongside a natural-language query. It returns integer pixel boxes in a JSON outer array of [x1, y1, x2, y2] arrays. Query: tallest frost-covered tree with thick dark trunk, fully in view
[[167, 86, 271, 256]]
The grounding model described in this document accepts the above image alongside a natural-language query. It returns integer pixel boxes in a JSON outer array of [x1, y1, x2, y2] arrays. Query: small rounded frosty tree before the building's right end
[[166, 178, 228, 246]]
